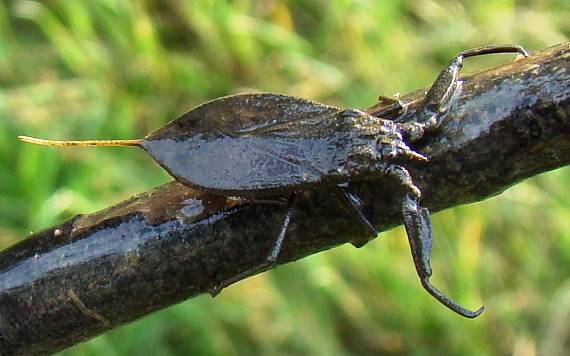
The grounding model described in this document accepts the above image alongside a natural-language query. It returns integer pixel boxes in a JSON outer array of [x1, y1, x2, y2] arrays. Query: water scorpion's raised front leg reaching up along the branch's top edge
[[410, 45, 528, 141]]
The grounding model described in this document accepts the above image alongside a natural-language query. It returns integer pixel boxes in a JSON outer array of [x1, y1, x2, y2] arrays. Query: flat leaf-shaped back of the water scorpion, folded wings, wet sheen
[[142, 93, 347, 196]]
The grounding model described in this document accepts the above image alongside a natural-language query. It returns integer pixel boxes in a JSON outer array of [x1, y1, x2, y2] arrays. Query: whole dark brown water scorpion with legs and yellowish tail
[[20, 46, 527, 318]]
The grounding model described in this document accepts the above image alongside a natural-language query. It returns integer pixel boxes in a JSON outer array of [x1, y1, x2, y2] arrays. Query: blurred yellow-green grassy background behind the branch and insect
[[0, 0, 570, 355]]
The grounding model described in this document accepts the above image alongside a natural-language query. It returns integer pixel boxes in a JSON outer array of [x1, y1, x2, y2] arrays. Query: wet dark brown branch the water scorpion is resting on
[[0, 43, 570, 355]]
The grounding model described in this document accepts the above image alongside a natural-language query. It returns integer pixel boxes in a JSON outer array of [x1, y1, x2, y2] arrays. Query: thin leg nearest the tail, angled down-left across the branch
[[208, 193, 297, 297]]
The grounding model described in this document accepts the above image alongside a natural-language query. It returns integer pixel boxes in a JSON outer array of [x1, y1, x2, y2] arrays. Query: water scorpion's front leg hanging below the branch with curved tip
[[388, 166, 484, 318]]
